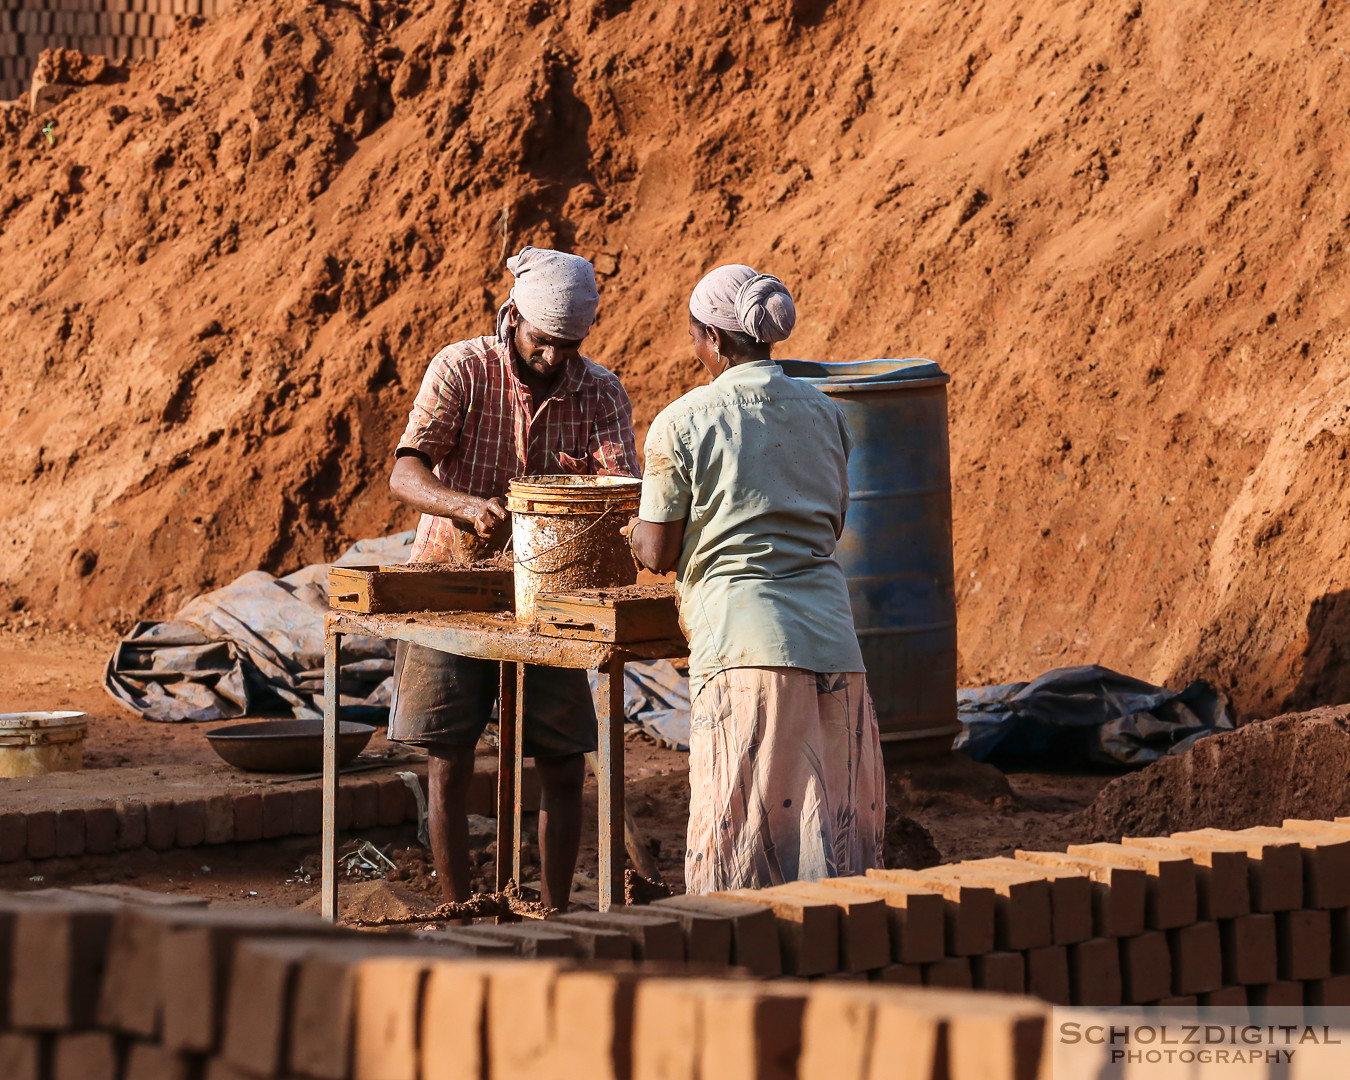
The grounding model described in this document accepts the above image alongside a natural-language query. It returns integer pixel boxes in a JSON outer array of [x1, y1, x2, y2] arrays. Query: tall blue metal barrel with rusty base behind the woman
[[780, 359, 961, 757]]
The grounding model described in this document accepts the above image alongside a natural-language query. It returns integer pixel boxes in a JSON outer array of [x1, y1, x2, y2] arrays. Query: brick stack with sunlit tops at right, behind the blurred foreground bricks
[[629, 822, 1350, 1006]]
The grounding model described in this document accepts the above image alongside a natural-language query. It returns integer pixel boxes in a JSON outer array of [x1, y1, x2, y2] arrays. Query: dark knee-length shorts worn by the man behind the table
[[389, 641, 597, 757]]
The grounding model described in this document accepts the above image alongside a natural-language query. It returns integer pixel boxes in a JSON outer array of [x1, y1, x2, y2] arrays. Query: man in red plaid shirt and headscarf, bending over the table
[[389, 247, 637, 909]]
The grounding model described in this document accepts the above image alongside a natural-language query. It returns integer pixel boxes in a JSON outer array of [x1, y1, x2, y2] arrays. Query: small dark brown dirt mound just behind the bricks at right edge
[[1084, 706, 1350, 840]]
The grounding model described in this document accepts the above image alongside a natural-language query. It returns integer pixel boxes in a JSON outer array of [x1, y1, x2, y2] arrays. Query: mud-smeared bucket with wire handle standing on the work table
[[506, 475, 643, 622]]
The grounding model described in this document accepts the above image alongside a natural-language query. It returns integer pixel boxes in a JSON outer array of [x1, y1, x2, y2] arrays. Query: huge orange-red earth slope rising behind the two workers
[[0, 0, 1350, 716]]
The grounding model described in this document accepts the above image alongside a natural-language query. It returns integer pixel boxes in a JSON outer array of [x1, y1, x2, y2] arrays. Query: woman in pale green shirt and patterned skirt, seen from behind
[[629, 265, 886, 892]]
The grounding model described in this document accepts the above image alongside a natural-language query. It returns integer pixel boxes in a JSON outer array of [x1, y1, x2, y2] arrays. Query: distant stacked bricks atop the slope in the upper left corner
[[0, 0, 235, 101]]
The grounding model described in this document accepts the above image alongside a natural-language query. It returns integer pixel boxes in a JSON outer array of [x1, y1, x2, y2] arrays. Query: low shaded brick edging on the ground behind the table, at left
[[0, 767, 539, 864]]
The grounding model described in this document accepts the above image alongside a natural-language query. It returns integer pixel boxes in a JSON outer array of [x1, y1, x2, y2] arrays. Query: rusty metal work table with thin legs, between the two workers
[[320, 610, 689, 922]]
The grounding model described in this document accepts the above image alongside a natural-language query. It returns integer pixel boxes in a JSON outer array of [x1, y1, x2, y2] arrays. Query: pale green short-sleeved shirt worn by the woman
[[639, 360, 863, 697]]
